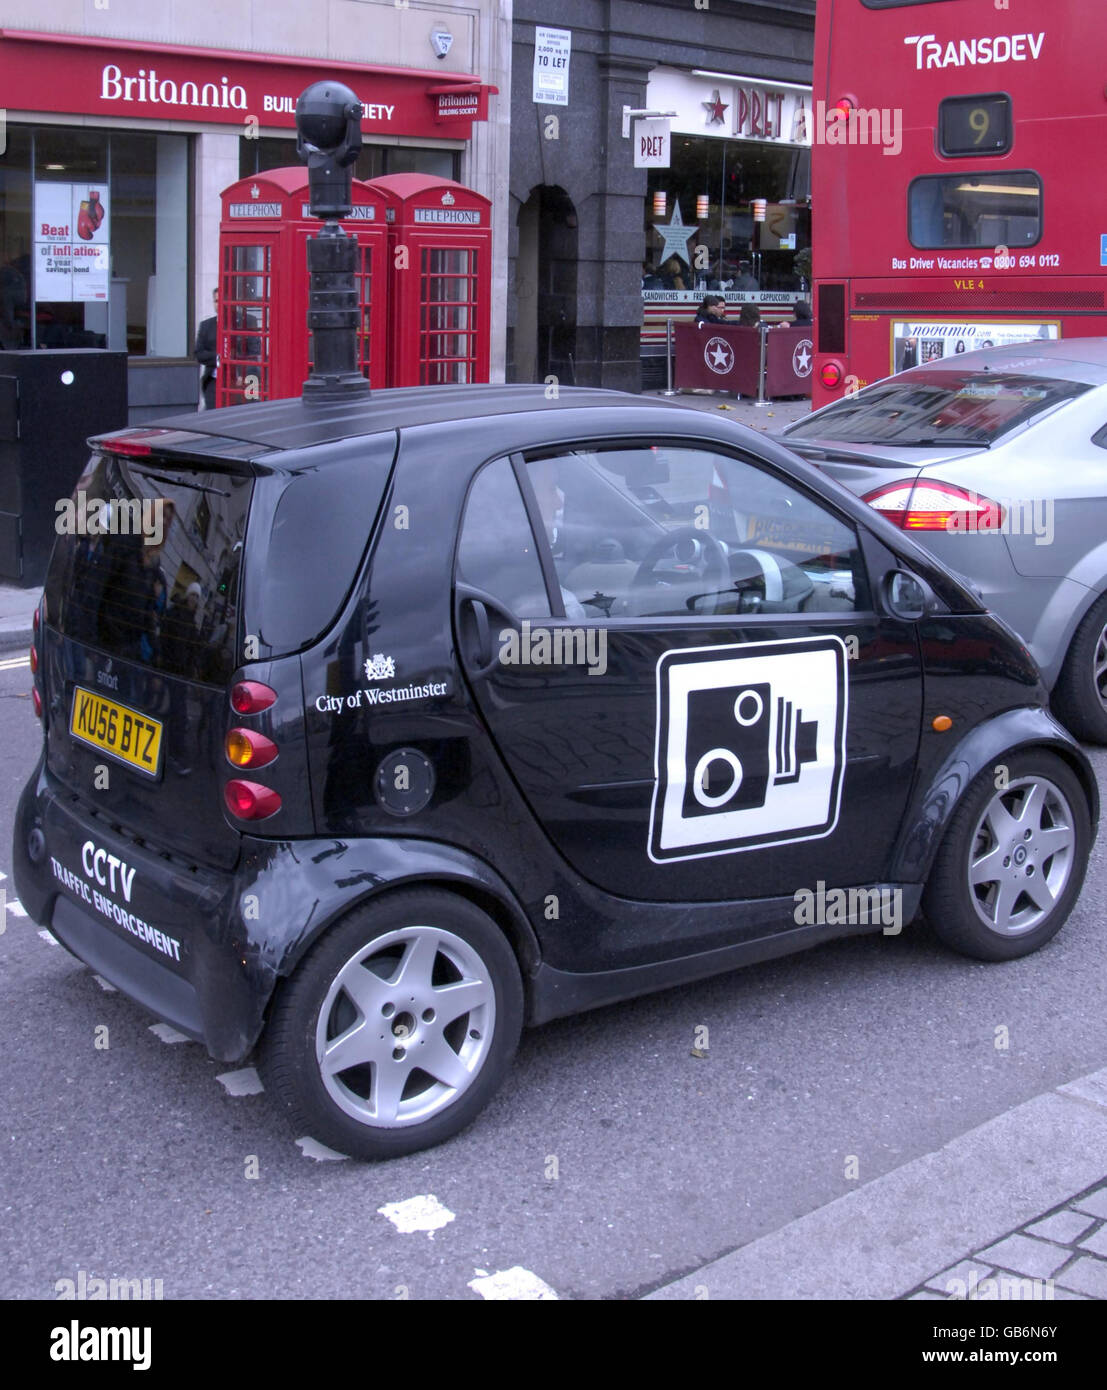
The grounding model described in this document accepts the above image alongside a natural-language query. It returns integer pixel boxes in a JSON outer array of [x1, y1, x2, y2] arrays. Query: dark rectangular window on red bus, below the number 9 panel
[[907, 170, 1042, 249]]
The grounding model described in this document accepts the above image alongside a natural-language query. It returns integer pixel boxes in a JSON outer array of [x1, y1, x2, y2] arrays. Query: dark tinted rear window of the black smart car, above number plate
[[46, 453, 253, 684]]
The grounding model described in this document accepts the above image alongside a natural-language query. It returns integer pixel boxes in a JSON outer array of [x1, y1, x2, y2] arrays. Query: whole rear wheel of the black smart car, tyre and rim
[[260, 890, 523, 1159]]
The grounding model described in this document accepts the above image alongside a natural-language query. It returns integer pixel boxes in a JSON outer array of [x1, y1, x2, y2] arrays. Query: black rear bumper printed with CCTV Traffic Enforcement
[[13, 763, 277, 1062]]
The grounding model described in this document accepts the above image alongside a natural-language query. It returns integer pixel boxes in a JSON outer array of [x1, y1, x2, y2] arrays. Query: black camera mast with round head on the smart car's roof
[[296, 82, 369, 402]]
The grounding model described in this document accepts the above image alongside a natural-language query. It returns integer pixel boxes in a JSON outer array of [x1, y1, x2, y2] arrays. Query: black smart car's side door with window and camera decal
[[455, 441, 922, 902]]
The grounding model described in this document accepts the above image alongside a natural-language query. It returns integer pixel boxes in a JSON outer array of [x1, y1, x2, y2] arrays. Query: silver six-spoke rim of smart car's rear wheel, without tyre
[[316, 926, 495, 1129]]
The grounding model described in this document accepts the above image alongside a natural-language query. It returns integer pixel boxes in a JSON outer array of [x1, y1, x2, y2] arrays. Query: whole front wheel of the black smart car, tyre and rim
[[922, 749, 1092, 960]]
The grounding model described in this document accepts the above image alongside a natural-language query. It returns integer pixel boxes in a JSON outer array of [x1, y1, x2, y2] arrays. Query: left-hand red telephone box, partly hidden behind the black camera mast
[[216, 165, 389, 406]]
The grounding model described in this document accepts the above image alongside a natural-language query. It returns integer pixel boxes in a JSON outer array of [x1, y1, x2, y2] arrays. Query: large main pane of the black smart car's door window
[[527, 445, 871, 617]]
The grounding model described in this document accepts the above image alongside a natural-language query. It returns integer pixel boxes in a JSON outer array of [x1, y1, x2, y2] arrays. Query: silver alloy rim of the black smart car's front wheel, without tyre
[[968, 777, 1076, 937]]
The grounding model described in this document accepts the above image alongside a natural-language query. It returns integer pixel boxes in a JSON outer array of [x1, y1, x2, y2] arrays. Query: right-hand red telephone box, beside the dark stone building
[[366, 174, 492, 386]]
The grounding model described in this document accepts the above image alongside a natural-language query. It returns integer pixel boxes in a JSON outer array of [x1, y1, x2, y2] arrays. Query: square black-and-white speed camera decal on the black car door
[[649, 637, 848, 863]]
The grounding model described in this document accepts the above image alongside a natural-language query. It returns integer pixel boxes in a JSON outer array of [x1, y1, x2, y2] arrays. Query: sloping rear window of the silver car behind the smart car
[[787, 371, 1090, 448]]
